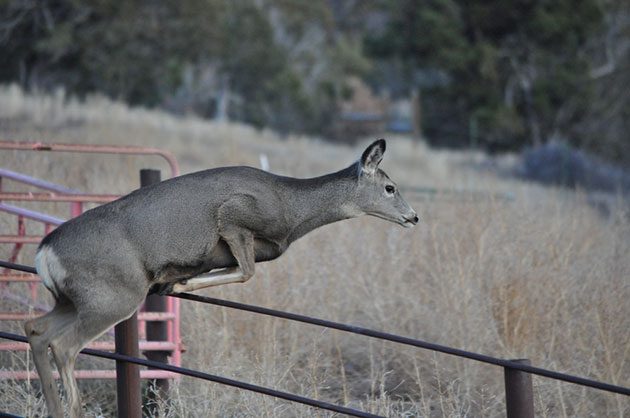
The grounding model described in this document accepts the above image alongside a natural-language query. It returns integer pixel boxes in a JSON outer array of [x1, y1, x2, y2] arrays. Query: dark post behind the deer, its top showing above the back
[[140, 169, 169, 416]]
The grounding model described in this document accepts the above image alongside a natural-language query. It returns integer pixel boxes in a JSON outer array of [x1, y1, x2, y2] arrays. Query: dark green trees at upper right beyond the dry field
[[366, 0, 602, 150]]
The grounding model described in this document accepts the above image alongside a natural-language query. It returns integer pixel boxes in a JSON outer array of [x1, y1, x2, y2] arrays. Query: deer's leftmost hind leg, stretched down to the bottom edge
[[24, 300, 76, 418]]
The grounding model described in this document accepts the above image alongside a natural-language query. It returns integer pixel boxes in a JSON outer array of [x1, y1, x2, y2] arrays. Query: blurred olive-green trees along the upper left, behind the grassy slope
[[0, 0, 366, 132]]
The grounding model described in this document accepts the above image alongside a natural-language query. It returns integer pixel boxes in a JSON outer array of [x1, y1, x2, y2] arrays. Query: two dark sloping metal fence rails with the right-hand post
[[0, 261, 630, 417]]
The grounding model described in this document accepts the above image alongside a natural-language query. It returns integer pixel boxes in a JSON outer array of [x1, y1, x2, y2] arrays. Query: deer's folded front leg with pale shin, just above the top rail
[[173, 228, 255, 293]]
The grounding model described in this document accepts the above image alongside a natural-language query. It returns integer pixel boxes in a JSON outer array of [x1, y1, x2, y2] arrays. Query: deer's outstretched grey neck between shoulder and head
[[288, 165, 361, 243]]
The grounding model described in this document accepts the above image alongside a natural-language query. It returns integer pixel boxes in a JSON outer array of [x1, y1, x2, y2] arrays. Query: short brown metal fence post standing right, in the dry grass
[[504, 359, 534, 418]]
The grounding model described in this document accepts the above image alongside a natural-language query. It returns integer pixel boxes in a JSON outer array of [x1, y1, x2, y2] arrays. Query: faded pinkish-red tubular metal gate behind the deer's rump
[[0, 141, 182, 379]]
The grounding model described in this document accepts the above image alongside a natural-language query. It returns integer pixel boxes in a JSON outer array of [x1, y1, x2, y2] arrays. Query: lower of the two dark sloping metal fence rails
[[0, 331, 383, 418]]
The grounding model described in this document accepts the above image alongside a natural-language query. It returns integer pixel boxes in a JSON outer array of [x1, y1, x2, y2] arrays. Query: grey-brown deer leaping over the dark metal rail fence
[[24, 139, 419, 418]]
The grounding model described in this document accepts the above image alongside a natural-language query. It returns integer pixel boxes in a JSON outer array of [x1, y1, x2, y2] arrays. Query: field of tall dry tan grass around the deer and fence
[[0, 84, 630, 417]]
